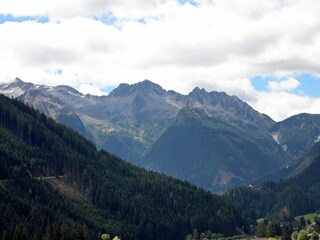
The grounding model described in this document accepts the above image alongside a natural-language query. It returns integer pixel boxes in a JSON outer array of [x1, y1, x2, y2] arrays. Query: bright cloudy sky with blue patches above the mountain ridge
[[0, 0, 320, 121]]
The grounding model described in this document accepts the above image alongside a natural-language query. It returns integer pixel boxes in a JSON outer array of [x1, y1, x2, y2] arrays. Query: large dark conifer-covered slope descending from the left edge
[[0, 96, 249, 239]]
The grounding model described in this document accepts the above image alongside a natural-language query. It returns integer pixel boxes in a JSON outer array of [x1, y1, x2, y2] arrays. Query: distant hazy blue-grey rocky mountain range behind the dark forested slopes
[[0, 79, 320, 192]]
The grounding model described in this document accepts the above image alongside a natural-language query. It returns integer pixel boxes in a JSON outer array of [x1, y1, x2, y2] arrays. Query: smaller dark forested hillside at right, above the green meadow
[[224, 143, 320, 220]]
